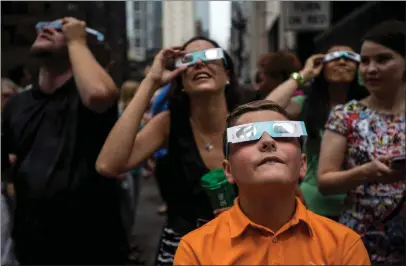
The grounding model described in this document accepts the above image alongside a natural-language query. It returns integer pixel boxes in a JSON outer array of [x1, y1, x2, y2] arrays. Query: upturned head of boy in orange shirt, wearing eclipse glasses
[[223, 100, 306, 189]]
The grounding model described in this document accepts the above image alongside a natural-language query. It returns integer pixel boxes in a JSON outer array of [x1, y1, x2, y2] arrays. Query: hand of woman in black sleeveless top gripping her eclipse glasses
[[147, 47, 187, 88]]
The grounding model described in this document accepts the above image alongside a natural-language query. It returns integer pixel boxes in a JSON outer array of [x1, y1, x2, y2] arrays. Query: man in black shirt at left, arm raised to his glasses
[[2, 18, 128, 265]]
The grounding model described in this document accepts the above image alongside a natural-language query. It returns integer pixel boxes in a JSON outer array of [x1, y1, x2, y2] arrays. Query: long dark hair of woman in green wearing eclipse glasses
[[303, 45, 369, 152]]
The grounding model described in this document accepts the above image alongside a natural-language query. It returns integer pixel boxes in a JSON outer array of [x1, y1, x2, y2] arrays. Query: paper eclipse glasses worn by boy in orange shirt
[[225, 121, 307, 158]]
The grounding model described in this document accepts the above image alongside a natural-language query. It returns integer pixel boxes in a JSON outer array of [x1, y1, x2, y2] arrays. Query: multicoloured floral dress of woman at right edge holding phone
[[325, 100, 406, 265]]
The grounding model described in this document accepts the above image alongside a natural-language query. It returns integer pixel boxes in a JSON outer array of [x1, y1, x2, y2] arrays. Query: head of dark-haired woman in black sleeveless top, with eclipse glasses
[[167, 36, 241, 113]]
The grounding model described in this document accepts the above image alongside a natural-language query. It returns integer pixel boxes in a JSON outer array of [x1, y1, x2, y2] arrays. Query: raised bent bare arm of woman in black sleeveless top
[[96, 77, 170, 177]]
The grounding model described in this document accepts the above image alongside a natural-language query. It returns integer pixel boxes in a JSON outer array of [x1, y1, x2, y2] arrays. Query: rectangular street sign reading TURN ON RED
[[282, 1, 330, 31]]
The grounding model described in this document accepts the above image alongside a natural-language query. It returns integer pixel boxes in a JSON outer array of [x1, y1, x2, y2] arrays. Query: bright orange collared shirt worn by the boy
[[174, 198, 371, 265]]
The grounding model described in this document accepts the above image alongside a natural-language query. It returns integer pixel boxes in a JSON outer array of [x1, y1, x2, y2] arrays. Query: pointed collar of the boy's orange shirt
[[229, 197, 314, 238]]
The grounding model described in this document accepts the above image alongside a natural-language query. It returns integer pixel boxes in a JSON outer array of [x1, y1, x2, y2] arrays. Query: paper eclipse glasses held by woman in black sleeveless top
[[175, 48, 227, 67]]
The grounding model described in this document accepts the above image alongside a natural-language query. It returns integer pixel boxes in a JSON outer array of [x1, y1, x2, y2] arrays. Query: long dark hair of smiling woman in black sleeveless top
[[160, 36, 241, 114]]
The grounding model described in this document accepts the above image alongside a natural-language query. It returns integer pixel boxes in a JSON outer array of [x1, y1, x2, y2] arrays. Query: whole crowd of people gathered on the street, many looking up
[[1, 17, 406, 265]]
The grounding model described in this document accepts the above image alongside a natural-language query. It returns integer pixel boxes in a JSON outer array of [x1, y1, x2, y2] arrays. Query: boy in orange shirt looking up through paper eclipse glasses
[[174, 100, 371, 265]]
